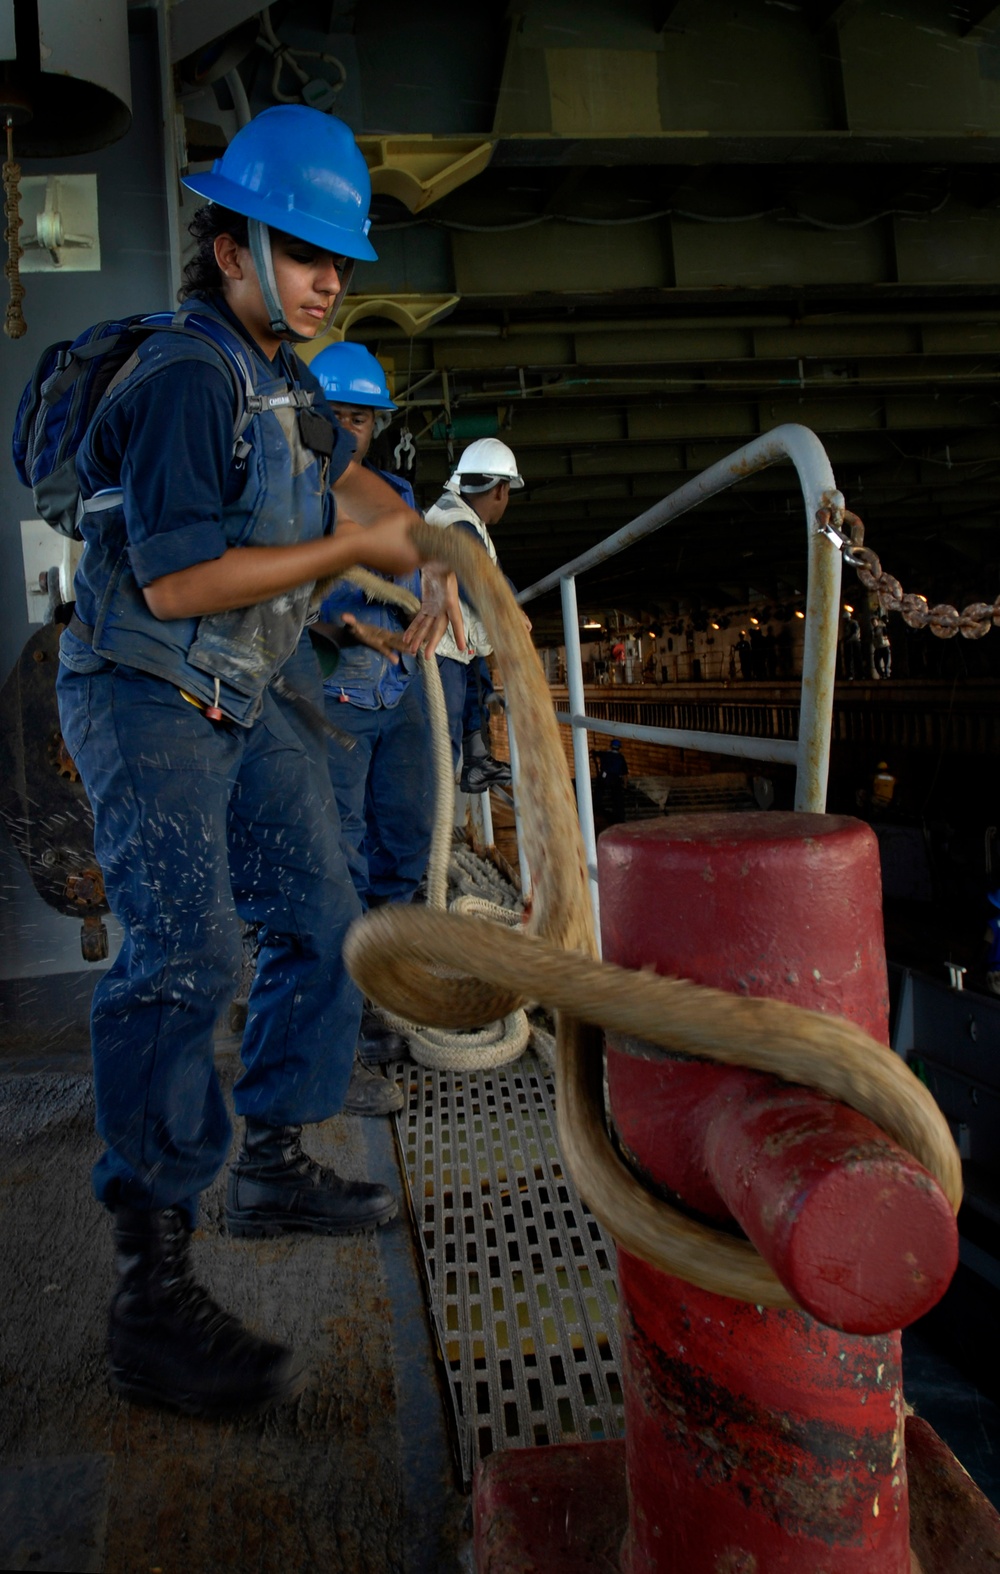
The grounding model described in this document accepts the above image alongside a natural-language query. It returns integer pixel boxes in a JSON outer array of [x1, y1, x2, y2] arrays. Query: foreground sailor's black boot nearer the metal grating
[[225, 1121, 397, 1237]]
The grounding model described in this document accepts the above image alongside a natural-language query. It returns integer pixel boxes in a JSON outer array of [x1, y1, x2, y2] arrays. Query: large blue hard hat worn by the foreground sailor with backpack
[[183, 104, 378, 263]]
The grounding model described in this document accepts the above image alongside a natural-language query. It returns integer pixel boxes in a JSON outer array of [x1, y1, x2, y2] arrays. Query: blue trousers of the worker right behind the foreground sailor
[[326, 676, 434, 908]]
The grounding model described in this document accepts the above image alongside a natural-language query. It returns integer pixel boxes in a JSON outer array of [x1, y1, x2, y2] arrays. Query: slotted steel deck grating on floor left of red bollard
[[397, 1051, 624, 1481]]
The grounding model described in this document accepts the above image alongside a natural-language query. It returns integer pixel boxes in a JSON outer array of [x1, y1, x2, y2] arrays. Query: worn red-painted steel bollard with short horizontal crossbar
[[600, 814, 957, 1574]]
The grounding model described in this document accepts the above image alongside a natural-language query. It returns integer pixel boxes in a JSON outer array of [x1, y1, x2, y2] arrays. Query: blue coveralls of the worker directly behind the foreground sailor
[[321, 466, 433, 908]]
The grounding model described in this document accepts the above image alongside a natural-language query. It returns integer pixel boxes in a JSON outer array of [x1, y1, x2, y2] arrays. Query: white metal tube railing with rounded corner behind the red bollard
[[512, 425, 844, 933]]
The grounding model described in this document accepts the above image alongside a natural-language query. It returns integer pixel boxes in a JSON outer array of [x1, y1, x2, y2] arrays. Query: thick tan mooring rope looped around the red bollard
[[345, 524, 962, 1306]]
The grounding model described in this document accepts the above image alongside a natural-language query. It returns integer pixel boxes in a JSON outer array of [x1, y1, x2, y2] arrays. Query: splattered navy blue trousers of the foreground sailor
[[58, 658, 361, 1221]]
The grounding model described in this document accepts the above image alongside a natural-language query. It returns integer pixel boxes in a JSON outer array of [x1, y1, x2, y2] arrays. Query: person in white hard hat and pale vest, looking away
[[427, 438, 531, 792]]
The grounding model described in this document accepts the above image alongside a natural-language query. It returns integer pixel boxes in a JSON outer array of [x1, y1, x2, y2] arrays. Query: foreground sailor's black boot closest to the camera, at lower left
[[109, 1207, 306, 1417]]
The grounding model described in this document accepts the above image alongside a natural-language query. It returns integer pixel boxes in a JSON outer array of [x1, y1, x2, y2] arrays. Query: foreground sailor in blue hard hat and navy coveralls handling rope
[[58, 105, 457, 1415]]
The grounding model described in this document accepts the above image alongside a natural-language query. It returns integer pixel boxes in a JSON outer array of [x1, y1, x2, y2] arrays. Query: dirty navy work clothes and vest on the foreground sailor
[[58, 301, 361, 1221]]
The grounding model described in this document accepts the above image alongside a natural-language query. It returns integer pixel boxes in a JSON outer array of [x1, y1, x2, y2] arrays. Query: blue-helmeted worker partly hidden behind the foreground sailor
[[310, 343, 435, 1076]]
